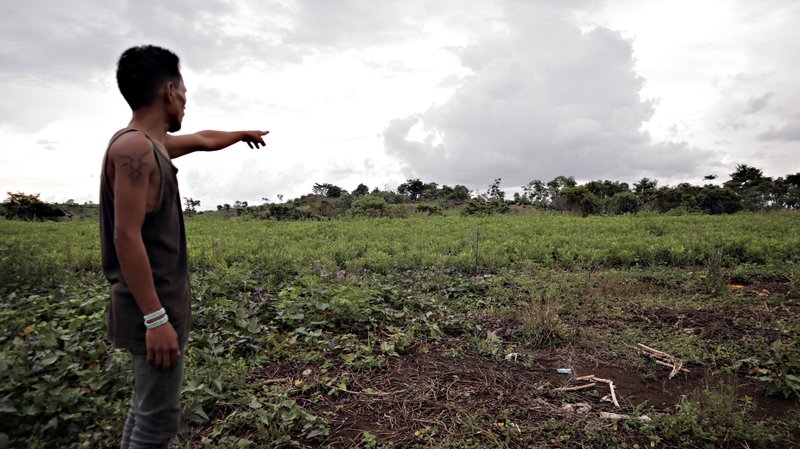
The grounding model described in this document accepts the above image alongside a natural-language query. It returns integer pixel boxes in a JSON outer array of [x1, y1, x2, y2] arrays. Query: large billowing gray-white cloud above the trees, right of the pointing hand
[[384, 10, 710, 186]]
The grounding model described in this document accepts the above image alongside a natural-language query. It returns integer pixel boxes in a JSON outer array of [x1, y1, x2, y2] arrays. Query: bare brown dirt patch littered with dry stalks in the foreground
[[255, 338, 798, 447]]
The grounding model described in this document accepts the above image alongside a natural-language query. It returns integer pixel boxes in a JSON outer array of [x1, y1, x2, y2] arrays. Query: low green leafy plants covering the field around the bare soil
[[0, 208, 800, 448]]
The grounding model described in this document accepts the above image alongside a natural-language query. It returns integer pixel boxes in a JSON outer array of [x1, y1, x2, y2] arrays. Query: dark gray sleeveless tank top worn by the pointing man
[[100, 128, 191, 354]]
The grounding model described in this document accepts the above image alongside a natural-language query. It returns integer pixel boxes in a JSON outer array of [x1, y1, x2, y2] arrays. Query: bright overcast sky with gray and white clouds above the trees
[[0, 0, 800, 209]]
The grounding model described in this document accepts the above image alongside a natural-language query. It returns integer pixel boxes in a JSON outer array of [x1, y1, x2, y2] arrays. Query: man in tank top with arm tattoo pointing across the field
[[100, 45, 268, 449]]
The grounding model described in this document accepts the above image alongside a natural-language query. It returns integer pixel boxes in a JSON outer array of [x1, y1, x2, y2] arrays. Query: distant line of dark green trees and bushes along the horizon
[[0, 164, 800, 220]]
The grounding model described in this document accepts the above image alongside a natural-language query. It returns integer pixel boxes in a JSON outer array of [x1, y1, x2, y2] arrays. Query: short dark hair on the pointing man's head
[[117, 45, 181, 111]]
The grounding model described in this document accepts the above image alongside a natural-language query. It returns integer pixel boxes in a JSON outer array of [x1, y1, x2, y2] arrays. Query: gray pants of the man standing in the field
[[122, 348, 185, 449]]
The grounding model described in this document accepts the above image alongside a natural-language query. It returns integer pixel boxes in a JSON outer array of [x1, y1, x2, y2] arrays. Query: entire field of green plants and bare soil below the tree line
[[0, 212, 800, 448]]
